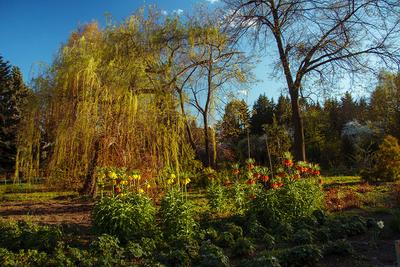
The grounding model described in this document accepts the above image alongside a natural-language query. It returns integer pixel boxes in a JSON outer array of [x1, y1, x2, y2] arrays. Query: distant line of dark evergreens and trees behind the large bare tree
[[218, 72, 400, 173]]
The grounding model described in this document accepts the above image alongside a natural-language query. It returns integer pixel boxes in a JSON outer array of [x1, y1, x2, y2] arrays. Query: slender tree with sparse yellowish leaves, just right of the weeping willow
[[185, 15, 251, 166]]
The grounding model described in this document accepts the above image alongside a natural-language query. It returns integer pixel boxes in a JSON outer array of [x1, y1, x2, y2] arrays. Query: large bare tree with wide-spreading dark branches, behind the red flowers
[[224, 0, 400, 160]]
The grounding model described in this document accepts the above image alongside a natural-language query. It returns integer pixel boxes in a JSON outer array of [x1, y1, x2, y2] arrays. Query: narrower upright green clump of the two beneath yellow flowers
[[160, 188, 197, 240]]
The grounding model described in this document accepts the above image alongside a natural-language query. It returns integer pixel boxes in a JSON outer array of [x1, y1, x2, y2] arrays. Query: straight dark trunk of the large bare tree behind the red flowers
[[289, 89, 306, 161]]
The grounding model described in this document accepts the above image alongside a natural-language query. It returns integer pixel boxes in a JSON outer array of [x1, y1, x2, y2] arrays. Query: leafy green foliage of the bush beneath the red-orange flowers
[[249, 179, 323, 226]]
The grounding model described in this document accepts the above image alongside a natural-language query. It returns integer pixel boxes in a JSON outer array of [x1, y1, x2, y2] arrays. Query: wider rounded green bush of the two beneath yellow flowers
[[92, 194, 156, 243]]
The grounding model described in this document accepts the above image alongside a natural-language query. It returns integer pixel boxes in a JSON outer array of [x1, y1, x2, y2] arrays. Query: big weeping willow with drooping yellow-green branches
[[16, 12, 197, 194]]
